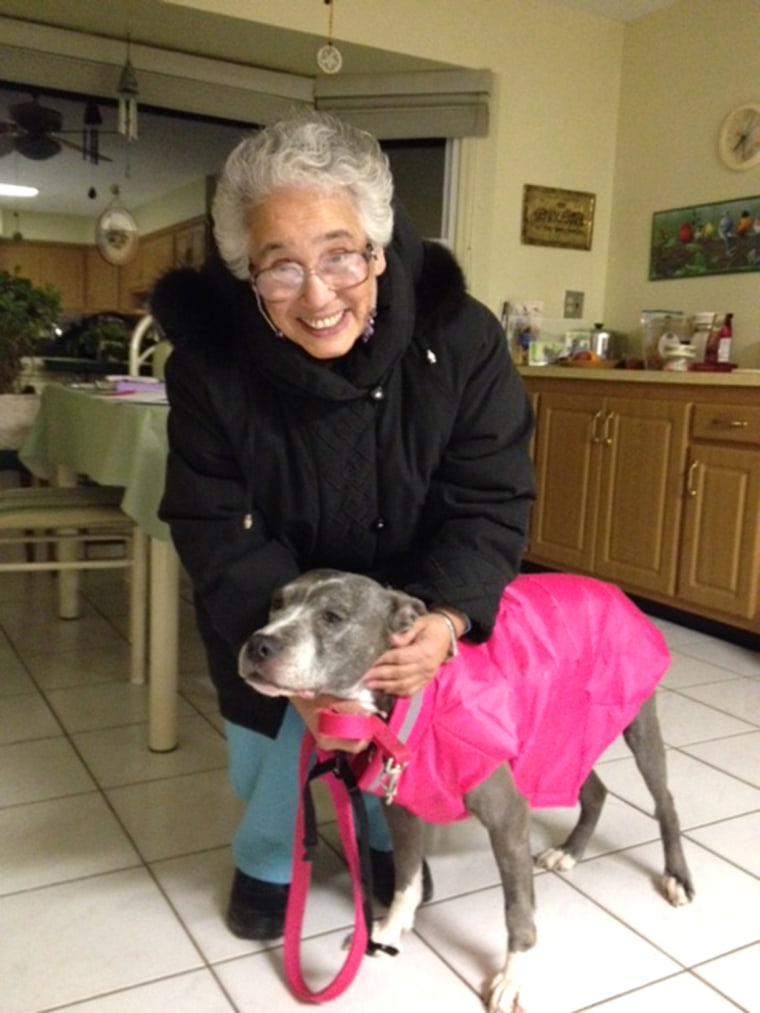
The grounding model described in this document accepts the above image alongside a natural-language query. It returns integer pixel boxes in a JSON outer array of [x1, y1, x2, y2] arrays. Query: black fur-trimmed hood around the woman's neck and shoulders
[[151, 212, 466, 399]]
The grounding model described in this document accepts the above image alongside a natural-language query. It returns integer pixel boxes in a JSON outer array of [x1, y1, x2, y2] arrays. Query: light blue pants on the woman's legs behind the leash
[[225, 707, 391, 883]]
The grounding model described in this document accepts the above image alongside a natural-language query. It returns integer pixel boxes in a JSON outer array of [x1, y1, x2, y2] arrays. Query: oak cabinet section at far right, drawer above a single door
[[678, 403, 760, 619]]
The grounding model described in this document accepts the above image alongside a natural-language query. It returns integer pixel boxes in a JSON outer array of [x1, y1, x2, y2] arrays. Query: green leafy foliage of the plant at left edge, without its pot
[[0, 270, 61, 394]]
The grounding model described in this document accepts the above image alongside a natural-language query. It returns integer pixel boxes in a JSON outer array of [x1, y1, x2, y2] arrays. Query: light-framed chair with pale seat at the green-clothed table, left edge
[[0, 485, 148, 683]]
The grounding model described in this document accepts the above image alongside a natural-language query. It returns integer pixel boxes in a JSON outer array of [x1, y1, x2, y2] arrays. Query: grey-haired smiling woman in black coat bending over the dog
[[152, 113, 533, 939]]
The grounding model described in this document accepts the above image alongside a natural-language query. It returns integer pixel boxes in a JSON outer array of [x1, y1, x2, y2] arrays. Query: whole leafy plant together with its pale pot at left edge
[[0, 270, 61, 455]]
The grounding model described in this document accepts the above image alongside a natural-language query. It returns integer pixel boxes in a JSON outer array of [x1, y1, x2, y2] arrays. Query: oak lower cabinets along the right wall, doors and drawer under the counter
[[524, 369, 760, 633]]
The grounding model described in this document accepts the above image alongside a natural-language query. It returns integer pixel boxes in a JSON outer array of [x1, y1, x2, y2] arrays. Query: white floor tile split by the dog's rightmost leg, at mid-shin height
[[600, 750, 760, 828]]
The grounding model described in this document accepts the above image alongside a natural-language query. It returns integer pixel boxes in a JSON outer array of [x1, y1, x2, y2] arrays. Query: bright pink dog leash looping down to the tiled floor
[[285, 710, 409, 1003]]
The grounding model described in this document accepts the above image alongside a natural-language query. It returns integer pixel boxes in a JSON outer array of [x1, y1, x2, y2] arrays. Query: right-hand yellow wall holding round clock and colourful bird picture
[[606, 0, 760, 369]]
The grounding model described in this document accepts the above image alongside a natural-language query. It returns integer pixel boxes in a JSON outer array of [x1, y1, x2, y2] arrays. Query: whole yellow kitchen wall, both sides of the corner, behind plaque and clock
[[187, 0, 760, 368]]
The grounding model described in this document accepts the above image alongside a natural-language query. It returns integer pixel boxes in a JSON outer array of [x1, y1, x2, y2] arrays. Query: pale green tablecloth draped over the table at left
[[19, 384, 169, 541]]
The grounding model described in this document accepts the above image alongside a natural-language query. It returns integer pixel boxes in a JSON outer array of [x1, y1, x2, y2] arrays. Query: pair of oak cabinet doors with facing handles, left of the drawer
[[530, 386, 688, 594]]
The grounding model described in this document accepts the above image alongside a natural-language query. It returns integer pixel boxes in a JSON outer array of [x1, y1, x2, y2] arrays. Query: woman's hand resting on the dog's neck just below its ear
[[364, 612, 451, 696]]
